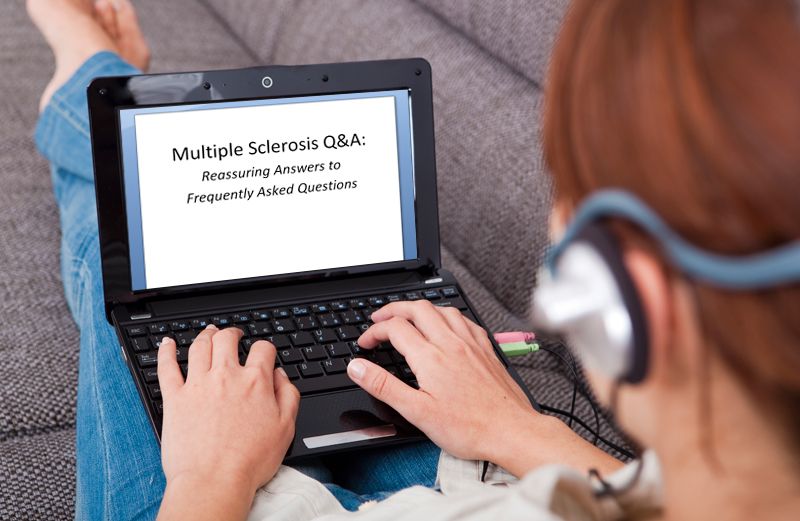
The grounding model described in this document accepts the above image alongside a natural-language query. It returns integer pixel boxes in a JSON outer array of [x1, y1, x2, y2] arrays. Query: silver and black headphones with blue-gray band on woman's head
[[532, 190, 800, 384]]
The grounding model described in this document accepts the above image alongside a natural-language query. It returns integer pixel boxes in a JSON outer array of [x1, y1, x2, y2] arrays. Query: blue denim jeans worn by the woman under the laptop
[[35, 52, 439, 520]]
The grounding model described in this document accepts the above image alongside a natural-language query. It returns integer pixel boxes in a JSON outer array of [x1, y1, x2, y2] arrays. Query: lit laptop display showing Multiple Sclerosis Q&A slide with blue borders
[[119, 90, 417, 291]]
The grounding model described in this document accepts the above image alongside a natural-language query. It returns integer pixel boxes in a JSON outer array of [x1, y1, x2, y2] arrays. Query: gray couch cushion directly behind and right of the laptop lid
[[203, 0, 550, 316]]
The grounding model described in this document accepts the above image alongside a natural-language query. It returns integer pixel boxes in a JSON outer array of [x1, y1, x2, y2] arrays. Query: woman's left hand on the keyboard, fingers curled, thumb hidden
[[158, 326, 300, 519]]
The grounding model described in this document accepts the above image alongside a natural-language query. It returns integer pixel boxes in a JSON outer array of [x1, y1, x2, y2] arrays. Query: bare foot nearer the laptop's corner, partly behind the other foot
[[94, 0, 150, 72]]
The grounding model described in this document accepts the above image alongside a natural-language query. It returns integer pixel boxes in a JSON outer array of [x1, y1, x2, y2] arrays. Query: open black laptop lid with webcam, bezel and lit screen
[[88, 59, 440, 312]]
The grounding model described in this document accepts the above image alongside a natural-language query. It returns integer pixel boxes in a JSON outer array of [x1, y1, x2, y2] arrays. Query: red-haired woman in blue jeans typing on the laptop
[[28, 0, 800, 520]]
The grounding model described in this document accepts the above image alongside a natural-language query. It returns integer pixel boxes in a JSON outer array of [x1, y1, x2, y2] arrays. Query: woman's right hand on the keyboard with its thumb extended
[[347, 300, 619, 476]]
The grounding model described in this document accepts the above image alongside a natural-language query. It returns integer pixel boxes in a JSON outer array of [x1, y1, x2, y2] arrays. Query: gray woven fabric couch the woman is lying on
[[0, 0, 618, 519]]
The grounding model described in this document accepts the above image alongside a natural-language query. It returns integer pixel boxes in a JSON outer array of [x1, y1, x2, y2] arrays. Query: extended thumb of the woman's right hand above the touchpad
[[347, 358, 426, 423]]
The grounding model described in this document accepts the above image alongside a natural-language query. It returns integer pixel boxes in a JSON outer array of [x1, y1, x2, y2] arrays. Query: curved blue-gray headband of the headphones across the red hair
[[546, 189, 800, 290]]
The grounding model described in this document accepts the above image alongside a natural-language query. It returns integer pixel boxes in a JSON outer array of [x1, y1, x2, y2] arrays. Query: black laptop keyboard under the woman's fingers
[[124, 286, 474, 414]]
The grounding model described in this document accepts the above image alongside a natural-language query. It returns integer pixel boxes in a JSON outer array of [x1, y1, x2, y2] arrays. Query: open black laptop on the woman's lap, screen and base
[[88, 59, 536, 460]]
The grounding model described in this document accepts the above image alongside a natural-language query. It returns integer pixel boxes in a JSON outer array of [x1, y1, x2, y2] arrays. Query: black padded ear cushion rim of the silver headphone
[[576, 223, 650, 384]]
